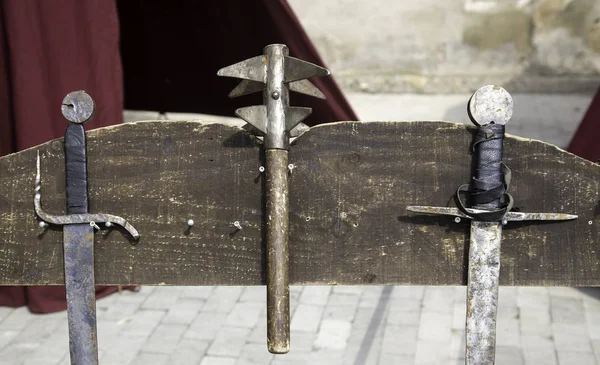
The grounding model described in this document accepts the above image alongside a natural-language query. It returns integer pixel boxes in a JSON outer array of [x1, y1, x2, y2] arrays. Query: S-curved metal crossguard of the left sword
[[33, 151, 140, 239]]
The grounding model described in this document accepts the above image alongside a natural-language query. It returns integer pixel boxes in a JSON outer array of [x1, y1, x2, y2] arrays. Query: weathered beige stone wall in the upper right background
[[289, 0, 600, 93]]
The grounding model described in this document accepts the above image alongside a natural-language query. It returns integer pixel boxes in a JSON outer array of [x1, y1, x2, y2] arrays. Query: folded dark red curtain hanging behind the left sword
[[0, 0, 123, 313]]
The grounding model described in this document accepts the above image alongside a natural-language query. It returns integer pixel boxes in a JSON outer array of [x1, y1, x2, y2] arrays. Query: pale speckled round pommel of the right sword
[[467, 85, 514, 126]]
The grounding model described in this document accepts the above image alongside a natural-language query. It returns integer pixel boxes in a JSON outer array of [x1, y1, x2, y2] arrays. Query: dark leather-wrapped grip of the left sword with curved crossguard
[[65, 123, 88, 214]]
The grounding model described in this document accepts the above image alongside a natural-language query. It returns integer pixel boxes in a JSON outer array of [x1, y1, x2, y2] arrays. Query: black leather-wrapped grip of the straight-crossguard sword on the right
[[469, 124, 506, 210]]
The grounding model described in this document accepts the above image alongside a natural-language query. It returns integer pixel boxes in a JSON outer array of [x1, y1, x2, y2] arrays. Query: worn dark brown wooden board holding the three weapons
[[0, 121, 600, 286]]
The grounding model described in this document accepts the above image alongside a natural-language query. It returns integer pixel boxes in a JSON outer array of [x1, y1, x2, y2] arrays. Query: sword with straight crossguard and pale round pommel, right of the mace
[[406, 85, 577, 365]]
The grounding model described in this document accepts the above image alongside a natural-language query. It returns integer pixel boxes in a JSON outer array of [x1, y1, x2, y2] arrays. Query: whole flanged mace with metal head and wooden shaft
[[217, 44, 329, 354]]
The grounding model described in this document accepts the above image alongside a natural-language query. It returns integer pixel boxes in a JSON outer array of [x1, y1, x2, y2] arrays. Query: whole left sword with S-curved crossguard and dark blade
[[34, 91, 140, 365]]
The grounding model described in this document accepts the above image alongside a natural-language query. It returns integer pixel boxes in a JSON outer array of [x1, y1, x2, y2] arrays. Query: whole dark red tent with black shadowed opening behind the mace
[[0, 0, 357, 313]]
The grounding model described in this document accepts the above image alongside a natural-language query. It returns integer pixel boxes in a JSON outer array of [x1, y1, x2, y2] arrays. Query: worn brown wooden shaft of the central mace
[[265, 149, 290, 354]]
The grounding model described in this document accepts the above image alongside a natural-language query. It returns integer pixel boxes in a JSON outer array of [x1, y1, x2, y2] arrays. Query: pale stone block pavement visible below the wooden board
[[0, 286, 600, 365]]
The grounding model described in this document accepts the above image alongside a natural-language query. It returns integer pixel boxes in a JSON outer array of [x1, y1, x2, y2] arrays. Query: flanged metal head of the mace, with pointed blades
[[217, 44, 329, 150]]
